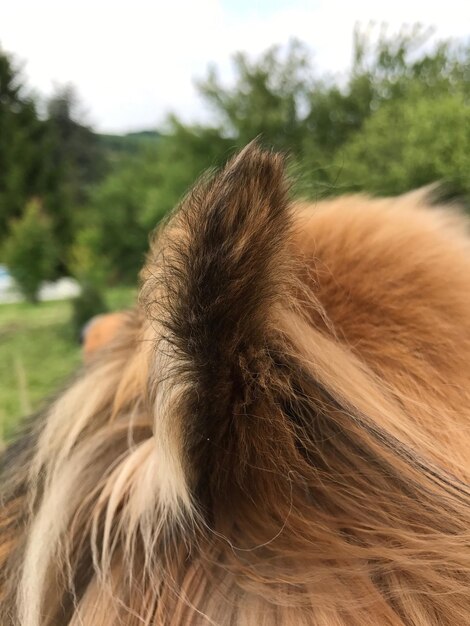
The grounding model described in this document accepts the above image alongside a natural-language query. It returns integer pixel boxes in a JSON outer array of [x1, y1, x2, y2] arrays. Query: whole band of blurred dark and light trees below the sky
[[0, 26, 470, 290]]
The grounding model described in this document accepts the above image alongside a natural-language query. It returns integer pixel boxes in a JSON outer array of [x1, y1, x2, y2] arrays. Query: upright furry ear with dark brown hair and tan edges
[[142, 143, 291, 502]]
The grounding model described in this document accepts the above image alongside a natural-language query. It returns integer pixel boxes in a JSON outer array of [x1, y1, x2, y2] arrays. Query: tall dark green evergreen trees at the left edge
[[0, 48, 105, 275]]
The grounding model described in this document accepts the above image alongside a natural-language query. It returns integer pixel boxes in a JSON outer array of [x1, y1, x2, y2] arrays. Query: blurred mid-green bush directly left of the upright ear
[[81, 119, 233, 284]]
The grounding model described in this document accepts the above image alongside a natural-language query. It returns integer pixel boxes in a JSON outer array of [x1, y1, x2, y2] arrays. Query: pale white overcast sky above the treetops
[[0, 0, 470, 132]]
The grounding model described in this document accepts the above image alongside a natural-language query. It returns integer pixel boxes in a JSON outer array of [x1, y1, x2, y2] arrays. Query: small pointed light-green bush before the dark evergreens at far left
[[3, 200, 57, 302]]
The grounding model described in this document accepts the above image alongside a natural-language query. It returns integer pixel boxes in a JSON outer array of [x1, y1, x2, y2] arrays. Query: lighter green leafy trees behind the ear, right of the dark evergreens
[[77, 27, 470, 282]]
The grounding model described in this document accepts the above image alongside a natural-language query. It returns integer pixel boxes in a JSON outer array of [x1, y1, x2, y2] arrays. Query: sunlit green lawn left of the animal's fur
[[0, 288, 136, 444]]
